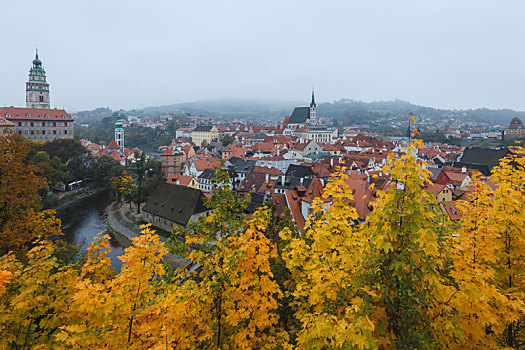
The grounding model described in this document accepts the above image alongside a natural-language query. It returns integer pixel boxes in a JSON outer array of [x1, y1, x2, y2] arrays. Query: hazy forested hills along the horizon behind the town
[[72, 99, 525, 126]]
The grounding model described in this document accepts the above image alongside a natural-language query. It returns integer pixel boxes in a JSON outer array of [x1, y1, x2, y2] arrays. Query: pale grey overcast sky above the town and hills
[[0, 0, 525, 112]]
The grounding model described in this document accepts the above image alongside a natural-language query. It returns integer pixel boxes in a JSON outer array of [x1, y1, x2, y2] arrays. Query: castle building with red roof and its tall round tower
[[0, 52, 74, 142]]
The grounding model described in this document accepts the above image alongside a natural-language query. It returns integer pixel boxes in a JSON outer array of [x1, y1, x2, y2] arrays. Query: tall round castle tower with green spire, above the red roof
[[26, 50, 51, 109]]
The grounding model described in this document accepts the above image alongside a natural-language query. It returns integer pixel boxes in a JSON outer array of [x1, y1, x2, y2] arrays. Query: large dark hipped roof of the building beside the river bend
[[143, 183, 209, 226]]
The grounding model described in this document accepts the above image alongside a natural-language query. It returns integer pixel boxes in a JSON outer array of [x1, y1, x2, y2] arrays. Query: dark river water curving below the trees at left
[[57, 191, 124, 272]]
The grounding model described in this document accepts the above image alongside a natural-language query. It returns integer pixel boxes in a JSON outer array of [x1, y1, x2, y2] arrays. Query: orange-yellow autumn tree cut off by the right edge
[[449, 148, 525, 349]]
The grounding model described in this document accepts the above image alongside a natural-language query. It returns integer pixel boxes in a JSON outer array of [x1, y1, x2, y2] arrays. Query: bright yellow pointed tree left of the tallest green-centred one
[[281, 171, 377, 349]]
